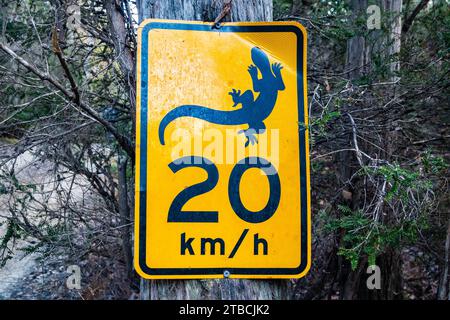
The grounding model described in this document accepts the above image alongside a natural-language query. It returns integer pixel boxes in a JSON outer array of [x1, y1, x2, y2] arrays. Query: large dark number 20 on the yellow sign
[[167, 156, 281, 223]]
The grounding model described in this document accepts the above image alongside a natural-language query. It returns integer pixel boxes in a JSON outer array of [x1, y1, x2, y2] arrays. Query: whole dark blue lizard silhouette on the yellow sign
[[159, 47, 285, 146]]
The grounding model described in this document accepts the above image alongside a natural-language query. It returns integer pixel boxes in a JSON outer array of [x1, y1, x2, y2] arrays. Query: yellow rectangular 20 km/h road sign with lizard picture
[[135, 20, 311, 279]]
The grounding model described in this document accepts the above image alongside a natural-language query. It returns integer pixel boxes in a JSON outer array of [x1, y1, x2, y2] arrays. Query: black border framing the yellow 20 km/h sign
[[135, 19, 311, 278]]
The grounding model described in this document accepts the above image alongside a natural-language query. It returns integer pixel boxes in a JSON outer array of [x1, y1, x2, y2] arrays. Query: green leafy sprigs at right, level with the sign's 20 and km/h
[[320, 158, 436, 269]]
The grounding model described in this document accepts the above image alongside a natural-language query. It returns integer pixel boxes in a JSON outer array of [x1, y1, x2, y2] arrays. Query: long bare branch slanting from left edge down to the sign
[[0, 42, 134, 159]]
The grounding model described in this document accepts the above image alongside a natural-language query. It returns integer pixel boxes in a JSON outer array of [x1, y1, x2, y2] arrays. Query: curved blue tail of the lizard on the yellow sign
[[159, 105, 247, 145]]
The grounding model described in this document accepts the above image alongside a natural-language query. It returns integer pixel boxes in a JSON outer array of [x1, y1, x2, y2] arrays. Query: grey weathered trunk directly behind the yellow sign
[[138, 0, 290, 300]]
